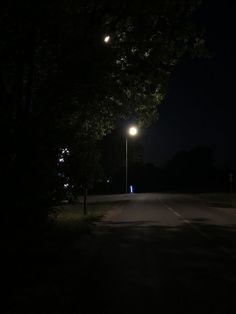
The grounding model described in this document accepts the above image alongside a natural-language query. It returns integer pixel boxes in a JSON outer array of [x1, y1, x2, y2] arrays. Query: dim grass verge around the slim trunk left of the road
[[6, 201, 122, 258]]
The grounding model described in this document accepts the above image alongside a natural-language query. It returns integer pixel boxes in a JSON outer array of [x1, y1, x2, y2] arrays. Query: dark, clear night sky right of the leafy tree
[[141, 0, 236, 168]]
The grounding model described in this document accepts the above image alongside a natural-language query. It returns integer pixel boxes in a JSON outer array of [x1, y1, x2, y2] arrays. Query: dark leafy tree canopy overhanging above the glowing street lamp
[[0, 0, 203, 136]]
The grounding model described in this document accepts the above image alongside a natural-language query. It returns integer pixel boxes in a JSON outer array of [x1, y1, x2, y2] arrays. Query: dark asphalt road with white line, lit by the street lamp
[[6, 194, 236, 314]]
